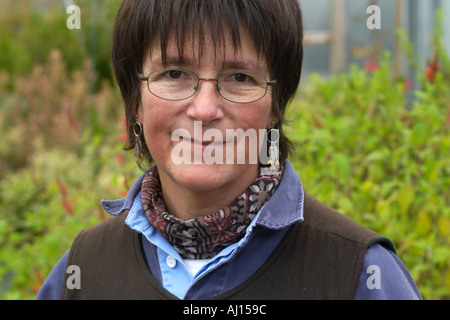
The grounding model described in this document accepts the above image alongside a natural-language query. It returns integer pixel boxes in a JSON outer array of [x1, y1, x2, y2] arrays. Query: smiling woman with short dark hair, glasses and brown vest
[[38, 0, 420, 299]]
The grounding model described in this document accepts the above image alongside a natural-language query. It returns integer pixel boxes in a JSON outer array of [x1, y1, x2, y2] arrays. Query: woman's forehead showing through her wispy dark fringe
[[143, 30, 267, 73]]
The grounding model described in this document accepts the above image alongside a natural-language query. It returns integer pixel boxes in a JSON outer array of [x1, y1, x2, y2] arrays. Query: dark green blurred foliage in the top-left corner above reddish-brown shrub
[[0, 0, 122, 90]]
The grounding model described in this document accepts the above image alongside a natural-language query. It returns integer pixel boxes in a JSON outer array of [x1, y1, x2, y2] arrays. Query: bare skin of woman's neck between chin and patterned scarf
[[159, 166, 258, 220]]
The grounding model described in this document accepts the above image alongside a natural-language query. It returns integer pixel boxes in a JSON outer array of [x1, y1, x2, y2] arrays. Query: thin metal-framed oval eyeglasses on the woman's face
[[139, 69, 276, 103]]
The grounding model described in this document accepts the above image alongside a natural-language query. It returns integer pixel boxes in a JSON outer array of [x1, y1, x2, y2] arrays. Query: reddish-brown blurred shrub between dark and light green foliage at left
[[0, 50, 123, 175]]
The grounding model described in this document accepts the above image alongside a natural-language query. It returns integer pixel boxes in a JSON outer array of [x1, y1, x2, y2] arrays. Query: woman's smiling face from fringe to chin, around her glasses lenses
[[138, 32, 276, 196]]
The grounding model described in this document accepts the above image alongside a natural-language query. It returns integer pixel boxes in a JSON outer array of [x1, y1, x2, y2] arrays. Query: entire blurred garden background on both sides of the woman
[[0, 0, 450, 299]]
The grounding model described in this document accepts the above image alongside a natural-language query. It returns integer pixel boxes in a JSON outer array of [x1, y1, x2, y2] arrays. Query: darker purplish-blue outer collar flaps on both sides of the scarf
[[102, 160, 304, 230]]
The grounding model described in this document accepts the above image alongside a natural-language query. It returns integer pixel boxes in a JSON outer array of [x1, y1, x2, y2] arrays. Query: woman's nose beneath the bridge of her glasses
[[187, 79, 224, 123]]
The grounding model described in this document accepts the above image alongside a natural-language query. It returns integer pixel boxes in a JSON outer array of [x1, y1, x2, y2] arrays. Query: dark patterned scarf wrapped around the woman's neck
[[141, 166, 284, 259]]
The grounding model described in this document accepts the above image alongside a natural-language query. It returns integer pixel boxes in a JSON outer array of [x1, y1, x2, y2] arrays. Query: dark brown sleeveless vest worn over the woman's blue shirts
[[62, 194, 395, 299]]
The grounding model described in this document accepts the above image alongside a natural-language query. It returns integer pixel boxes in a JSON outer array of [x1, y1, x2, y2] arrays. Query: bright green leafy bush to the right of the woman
[[289, 55, 450, 299]]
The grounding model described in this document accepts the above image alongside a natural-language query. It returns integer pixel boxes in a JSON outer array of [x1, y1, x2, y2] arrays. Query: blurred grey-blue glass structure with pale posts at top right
[[300, 0, 450, 74]]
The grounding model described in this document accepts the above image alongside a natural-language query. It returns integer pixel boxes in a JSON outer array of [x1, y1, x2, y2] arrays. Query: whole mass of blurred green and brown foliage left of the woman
[[0, 1, 135, 299]]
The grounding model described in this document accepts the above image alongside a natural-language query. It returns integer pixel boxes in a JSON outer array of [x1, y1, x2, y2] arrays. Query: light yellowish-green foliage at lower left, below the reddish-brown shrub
[[0, 140, 139, 299]]
